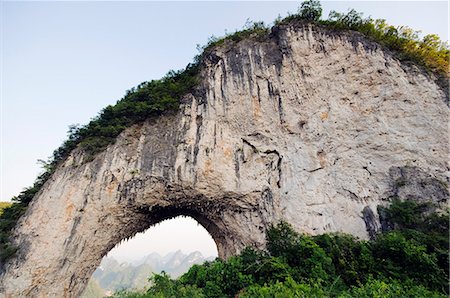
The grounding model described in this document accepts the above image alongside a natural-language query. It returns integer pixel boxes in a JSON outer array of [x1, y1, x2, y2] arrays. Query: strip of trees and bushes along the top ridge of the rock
[[0, 0, 450, 263]]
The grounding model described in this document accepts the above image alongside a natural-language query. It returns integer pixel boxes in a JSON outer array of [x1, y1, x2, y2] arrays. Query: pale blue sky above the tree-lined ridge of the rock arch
[[0, 1, 449, 253]]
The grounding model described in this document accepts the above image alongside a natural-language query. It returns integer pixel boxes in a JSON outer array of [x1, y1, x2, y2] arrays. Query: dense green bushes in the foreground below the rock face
[[111, 199, 449, 298]]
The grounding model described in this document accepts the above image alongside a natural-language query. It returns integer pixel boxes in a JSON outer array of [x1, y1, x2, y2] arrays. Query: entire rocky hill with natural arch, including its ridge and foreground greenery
[[0, 1, 450, 297]]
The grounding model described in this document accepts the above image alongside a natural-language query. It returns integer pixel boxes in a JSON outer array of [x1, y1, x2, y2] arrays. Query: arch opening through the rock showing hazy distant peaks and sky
[[82, 214, 218, 298]]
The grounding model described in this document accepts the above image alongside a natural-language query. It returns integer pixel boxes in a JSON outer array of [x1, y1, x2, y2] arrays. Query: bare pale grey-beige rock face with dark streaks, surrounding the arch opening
[[0, 25, 449, 297]]
